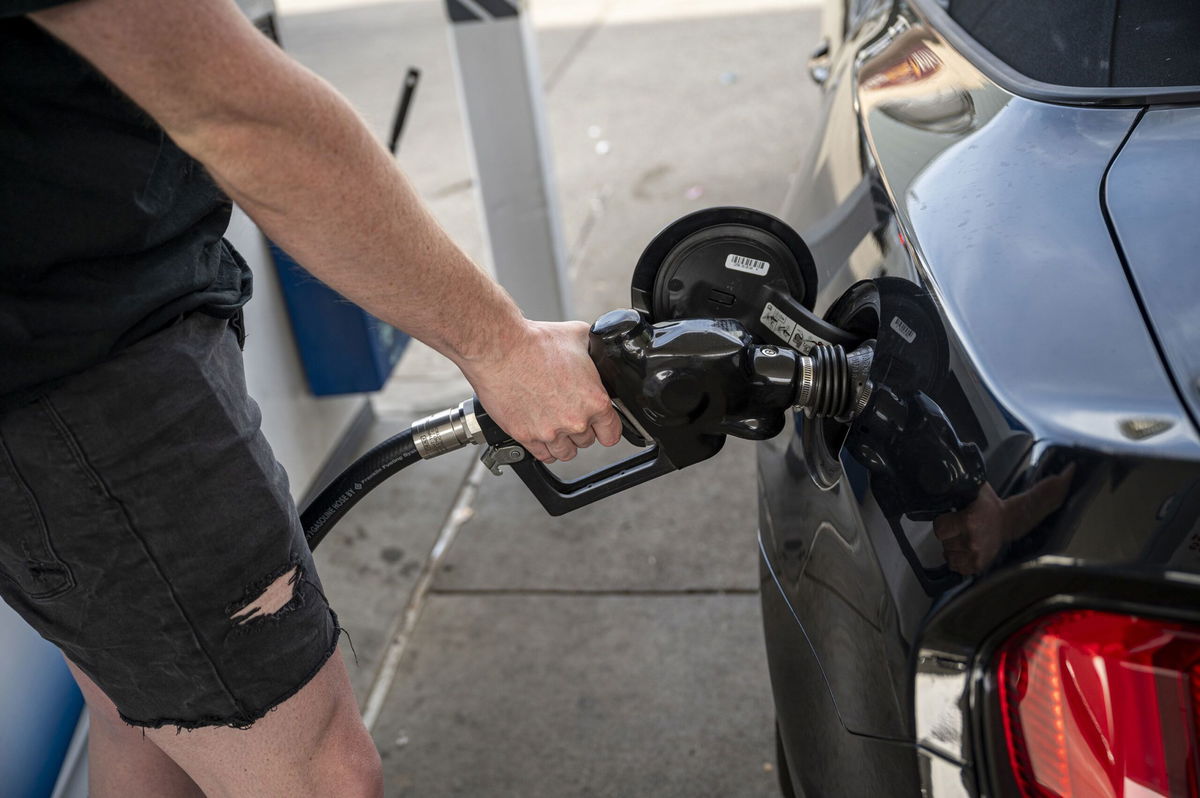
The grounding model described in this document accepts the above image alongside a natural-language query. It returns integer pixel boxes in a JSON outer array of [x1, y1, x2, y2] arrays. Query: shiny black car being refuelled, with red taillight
[[758, 0, 1200, 798]]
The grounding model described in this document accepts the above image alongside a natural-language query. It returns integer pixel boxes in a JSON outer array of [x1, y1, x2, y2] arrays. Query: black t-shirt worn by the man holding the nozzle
[[0, 0, 251, 408]]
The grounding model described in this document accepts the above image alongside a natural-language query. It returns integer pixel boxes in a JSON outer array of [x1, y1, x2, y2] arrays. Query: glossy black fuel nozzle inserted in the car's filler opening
[[446, 310, 872, 516]]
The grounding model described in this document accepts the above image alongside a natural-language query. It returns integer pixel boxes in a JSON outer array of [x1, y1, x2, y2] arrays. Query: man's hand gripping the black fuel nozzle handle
[[461, 322, 620, 463]]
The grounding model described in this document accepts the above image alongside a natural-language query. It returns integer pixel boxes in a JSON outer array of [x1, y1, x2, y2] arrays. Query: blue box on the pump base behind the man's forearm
[[270, 244, 408, 396]]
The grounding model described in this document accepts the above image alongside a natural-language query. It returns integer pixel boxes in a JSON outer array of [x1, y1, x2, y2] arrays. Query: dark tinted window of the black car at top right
[[940, 0, 1200, 88]]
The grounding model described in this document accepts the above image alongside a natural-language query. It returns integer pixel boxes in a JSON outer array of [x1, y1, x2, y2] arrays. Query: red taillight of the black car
[[996, 611, 1200, 798]]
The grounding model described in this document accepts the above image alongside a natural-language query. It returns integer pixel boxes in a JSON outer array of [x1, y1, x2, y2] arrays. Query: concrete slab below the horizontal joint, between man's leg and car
[[376, 593, 778, 798]]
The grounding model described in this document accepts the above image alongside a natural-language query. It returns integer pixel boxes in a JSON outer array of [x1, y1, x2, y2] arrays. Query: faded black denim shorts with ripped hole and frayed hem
[[0, 314, 338, 728]]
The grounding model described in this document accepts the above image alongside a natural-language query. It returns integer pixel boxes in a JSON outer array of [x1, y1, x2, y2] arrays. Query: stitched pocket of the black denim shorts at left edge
[[0, 440, 74, 599]]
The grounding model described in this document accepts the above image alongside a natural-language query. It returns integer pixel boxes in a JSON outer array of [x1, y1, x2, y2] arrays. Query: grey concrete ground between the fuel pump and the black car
[[280, 0, 820, 797]]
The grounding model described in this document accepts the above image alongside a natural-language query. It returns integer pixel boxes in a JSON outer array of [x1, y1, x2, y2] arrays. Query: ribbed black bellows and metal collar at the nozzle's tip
[[796, 341, 875, 422]]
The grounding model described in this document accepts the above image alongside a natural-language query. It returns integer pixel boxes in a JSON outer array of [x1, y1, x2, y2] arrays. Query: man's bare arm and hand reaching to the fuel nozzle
[[31, 0, 620, 461]]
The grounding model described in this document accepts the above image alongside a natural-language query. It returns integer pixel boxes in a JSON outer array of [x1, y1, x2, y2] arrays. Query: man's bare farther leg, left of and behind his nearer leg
[[67, 660, 204, 798]]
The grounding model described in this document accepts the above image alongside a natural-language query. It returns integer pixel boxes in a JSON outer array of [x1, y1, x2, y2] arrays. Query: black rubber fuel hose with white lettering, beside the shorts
[[300, 427, 421, 550]]
